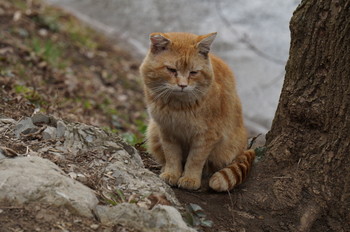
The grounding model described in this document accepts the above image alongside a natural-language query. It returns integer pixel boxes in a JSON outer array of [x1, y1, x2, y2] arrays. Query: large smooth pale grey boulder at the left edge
[[0, 157, 98, 218]]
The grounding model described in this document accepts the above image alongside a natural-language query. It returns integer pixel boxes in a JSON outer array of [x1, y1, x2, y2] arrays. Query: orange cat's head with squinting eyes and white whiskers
[[140, 32, 216, 102]]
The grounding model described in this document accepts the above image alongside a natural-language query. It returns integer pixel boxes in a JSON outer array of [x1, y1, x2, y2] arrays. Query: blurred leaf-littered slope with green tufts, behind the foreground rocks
[[0, 0, 145, 142]]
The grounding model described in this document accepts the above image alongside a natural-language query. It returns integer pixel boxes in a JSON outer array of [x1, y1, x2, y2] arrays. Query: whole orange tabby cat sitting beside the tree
[[140, 33, 255, 191]]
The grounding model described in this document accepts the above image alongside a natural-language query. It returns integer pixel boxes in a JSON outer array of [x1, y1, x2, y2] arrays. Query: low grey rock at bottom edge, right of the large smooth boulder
[[95, 203, 195, 232]]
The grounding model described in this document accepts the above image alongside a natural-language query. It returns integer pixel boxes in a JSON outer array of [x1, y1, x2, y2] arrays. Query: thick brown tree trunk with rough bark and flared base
[[234, 0, 350, 232]]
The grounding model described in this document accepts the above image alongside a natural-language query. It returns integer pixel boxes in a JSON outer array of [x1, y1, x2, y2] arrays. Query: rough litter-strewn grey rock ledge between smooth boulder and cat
[[63, 123, 180, 206]]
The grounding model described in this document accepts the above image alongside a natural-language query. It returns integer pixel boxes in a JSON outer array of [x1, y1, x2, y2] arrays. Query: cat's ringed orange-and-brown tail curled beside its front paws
[[209, 150, 255, 192]]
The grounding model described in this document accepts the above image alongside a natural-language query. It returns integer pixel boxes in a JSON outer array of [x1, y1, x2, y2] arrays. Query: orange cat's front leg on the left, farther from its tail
[[159, 139, 182, 186]]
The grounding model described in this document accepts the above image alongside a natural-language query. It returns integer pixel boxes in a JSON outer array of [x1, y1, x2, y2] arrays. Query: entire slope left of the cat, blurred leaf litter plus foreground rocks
[[0, 0, 197, 231]]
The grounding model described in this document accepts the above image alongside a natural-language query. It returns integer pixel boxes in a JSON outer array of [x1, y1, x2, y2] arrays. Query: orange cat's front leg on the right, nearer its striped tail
[[177, 139, 215, 190]]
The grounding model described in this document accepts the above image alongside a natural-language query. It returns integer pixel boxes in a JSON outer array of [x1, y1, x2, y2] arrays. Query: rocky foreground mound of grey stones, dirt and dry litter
[[0, 114, 194, 231]]
